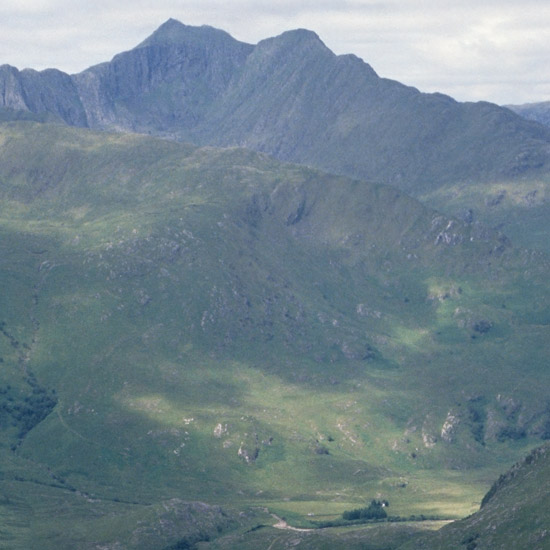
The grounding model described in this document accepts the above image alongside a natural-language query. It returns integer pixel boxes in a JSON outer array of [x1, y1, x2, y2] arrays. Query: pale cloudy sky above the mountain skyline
[[0, 0, 550, 105]]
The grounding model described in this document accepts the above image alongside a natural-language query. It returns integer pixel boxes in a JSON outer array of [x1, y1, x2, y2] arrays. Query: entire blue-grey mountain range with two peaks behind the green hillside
[[0, 19, 550, 253]]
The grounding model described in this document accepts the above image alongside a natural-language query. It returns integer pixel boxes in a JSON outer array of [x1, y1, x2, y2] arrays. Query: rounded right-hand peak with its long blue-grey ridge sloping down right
[[199, 31, 550, 194]]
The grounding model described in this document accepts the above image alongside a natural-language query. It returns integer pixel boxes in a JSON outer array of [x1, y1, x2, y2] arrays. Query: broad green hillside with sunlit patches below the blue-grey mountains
[[0, 122, 550, 548]]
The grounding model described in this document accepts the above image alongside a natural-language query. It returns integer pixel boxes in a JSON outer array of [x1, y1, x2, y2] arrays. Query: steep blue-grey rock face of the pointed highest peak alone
[[73, 20, 252, 138]]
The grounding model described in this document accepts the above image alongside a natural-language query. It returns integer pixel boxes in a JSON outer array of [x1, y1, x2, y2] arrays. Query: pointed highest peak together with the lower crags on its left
[[0, 20, 253, 135]]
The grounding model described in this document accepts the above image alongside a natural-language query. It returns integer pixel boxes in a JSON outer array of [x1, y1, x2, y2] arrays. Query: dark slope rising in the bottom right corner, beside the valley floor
[[400, 446, 550, 550]]
